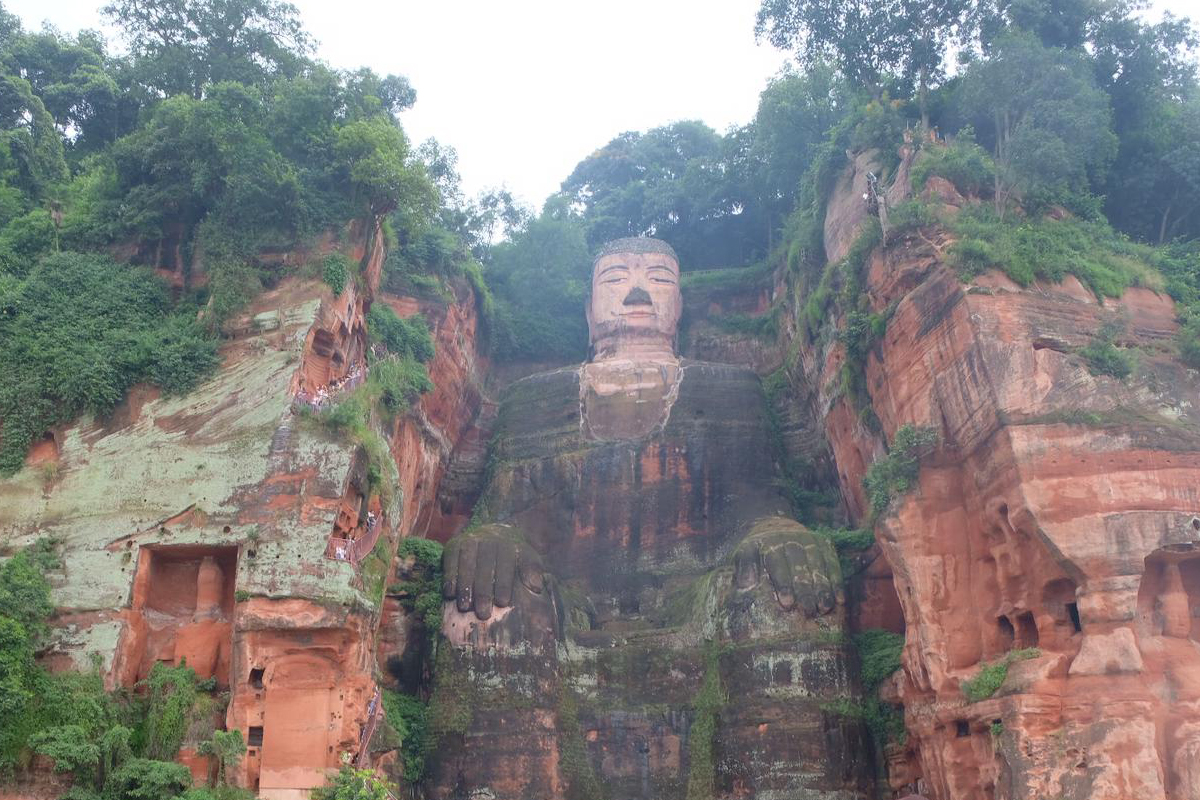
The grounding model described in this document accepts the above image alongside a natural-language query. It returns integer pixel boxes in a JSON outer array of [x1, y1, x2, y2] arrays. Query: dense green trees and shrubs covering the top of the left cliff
[[0, 0, 438, 475]]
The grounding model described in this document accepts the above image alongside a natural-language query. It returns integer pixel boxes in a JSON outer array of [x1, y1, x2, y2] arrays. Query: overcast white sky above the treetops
[[5, 0, 1200, 207]]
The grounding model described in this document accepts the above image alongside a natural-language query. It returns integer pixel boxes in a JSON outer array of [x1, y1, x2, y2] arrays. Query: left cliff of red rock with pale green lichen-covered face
[[0, 226, 480, 798]]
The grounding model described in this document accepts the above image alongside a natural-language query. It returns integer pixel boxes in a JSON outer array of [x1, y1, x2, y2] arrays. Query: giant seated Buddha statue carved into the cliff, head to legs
[[432, 237, 864, 800]]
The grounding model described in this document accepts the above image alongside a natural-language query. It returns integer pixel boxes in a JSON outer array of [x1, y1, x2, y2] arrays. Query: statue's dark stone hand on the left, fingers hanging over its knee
[[442, 525, 545, 620]]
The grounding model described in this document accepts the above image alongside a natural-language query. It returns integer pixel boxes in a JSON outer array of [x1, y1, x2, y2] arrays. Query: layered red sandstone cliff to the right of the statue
[[793, 149, 1200, 800]]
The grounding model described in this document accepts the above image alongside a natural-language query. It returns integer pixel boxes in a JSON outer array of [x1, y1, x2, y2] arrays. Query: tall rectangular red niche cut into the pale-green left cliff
[[118, 545, 238, 687]]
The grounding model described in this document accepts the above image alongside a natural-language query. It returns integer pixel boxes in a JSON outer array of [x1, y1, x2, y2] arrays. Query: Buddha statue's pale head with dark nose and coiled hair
[[588, 236, 683, 359]]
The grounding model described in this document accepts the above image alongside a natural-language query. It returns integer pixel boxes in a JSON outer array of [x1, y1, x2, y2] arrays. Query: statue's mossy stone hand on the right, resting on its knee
[[733, 517, 845, 616]]
